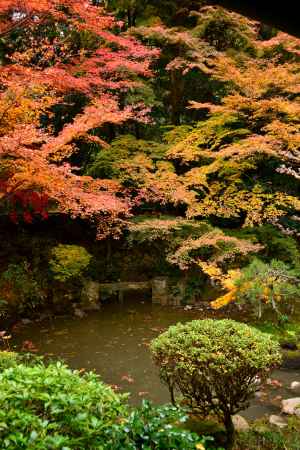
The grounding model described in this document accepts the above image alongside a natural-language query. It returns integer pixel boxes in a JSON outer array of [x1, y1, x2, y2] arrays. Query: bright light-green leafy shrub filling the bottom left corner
[[0, 363, 126, 450]]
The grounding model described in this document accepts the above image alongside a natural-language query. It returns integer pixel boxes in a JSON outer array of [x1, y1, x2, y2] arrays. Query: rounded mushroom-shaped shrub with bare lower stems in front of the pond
[[151, 319, 281, 448]]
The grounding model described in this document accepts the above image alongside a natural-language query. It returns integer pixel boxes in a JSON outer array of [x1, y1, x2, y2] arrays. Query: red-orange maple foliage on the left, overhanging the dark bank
[[0, 0, 157, 237]]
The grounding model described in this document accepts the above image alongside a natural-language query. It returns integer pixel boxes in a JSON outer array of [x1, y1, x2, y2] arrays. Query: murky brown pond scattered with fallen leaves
[[13, 298, 300, 419]]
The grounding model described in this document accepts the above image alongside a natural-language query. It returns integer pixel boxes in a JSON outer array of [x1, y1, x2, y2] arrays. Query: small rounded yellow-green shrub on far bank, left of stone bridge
[[49, 244, 92, 282]]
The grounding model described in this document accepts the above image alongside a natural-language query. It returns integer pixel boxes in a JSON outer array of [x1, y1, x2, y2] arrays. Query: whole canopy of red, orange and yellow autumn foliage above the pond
[[0, 0, 300, 307]]
